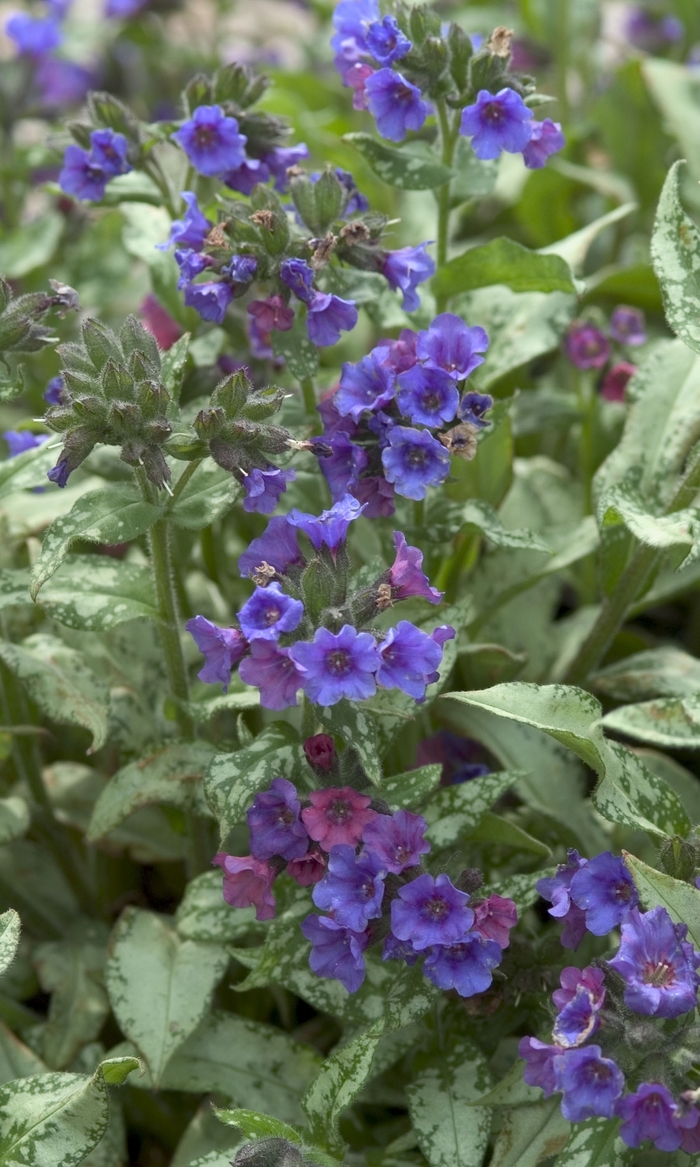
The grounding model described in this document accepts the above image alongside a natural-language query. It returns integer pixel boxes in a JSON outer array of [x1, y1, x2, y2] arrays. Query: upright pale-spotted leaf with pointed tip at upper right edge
[[651, 162, 700, 352]]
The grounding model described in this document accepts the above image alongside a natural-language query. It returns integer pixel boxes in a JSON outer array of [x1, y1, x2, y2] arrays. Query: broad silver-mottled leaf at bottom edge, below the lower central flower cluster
[[406, 1037, 491, 1167]]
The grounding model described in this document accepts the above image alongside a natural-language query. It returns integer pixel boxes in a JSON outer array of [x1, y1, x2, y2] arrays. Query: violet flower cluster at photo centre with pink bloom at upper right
[[186, 494, 455, 710]]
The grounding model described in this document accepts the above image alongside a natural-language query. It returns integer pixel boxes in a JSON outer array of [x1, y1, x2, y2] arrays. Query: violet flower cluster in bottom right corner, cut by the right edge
[[519, 851, 700, 1154]]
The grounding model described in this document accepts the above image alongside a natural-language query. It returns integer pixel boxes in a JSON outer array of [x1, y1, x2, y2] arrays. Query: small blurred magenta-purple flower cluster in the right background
[[564, 303, 648, 401]]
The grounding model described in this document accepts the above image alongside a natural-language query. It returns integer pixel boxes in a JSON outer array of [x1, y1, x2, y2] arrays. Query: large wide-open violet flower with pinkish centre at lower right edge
[[610, 908, 700, 1018]]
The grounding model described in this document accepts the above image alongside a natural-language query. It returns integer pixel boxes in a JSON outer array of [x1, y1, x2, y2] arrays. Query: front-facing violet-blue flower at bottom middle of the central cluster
[[289, 624, 380, 705]]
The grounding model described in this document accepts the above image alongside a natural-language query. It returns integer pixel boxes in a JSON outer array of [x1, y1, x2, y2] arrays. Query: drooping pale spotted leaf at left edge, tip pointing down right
[[0, 633, 107, 753]]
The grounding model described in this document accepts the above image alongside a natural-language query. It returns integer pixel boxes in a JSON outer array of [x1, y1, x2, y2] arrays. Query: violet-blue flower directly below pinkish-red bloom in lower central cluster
[[312, 844, 386, 932]]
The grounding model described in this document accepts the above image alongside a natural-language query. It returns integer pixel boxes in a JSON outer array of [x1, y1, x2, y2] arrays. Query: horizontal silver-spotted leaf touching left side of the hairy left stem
[[40, 555, 160, 631]]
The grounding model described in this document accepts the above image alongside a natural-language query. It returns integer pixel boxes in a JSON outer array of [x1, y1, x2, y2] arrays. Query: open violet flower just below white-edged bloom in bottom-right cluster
[[554, 1046, 625, 1120]]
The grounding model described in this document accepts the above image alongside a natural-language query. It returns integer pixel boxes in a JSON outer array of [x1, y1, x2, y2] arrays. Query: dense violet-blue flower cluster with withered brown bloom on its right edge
[[319, 313, 494, 517]]
